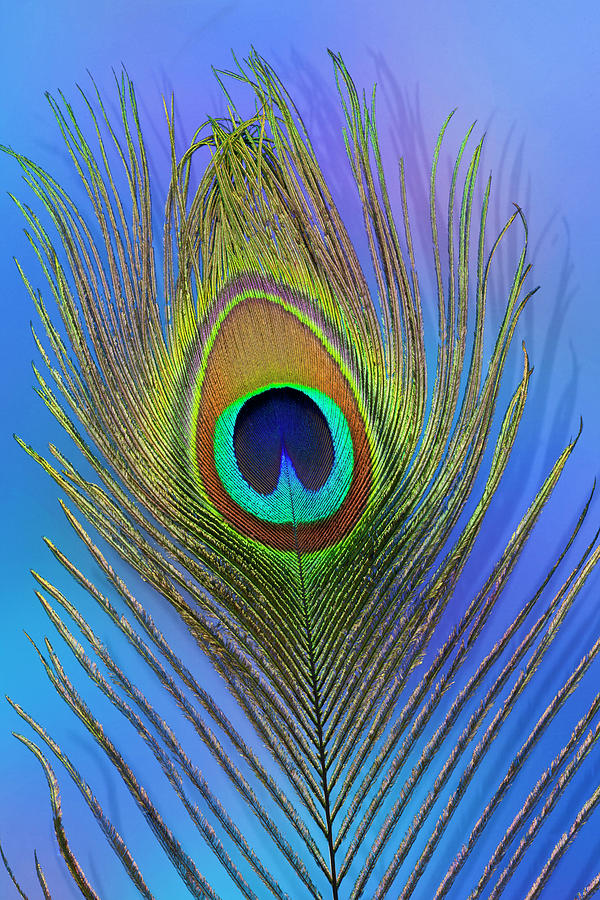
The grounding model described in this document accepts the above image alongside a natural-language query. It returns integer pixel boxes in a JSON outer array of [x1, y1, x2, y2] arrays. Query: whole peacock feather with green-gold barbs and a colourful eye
[[3, 53, 600, 900]]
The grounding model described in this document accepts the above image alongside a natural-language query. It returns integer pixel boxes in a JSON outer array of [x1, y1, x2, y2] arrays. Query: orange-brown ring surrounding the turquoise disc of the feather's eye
[[196, 297, 372, 553]]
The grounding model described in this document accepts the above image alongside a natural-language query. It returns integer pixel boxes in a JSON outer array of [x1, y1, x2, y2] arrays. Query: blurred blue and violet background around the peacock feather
[[0, 0, 600, 900]]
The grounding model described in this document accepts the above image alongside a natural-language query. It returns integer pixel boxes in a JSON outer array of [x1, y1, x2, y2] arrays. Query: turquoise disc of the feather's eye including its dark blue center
[[214, 384, 354, 525]]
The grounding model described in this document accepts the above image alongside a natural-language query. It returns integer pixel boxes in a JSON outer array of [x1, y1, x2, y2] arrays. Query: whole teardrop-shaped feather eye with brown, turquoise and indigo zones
[[190, 279, 372, 553]]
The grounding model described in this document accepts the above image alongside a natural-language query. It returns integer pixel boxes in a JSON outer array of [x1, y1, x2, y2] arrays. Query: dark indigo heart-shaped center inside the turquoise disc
[[233, 387, 334, 495]]
